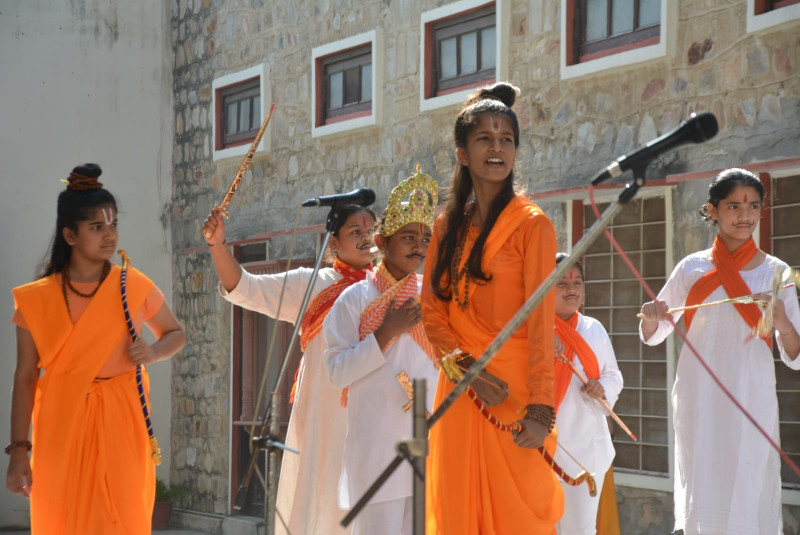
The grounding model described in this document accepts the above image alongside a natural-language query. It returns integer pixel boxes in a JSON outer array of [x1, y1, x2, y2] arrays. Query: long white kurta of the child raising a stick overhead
[[220, 268, 350, 535]]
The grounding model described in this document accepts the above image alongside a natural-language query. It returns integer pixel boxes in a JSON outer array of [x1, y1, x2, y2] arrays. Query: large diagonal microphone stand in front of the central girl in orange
[[341, 174, 649, 535]]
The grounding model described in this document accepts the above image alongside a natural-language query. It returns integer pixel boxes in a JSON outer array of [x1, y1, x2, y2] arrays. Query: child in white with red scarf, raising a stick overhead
[[203, 205, 375, 535]]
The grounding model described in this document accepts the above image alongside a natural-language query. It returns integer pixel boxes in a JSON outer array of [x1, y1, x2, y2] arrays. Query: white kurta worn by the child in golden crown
[[322, 277, 439, 509]]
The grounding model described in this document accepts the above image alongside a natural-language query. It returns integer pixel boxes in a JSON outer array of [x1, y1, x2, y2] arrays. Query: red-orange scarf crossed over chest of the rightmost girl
[[683, 236, 772, 347]]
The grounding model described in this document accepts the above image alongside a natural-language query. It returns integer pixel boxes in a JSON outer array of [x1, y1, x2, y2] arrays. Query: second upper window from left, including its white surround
[[311, 30, 384, 137]]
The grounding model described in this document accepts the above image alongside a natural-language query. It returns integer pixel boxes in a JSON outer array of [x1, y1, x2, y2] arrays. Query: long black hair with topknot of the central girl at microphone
[[433, 82, 519, 301]]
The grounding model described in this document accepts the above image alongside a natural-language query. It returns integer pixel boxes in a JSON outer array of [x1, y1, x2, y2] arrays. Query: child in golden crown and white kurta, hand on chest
[[323, 167, 438, 535]]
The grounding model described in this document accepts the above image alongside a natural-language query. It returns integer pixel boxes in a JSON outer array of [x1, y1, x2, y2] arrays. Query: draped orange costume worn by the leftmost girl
[[14, 266, 155, 535]]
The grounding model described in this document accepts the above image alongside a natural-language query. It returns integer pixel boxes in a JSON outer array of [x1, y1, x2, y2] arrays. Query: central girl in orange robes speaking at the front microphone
[[422, 83, 564, 535]]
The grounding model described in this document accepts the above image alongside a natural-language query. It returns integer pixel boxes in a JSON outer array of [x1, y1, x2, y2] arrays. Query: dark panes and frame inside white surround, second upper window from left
[[322, 46, 372, 122]]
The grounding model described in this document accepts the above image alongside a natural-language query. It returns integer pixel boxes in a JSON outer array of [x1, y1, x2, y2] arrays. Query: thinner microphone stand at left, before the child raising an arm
[[233, 206, 339, 535]]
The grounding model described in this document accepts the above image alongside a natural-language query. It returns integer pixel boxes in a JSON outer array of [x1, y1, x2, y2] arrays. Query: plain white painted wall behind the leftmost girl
[[0, 0, 173, 528]]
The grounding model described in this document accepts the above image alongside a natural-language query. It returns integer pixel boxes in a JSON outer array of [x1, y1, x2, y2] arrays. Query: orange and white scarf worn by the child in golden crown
[[340, 260, 436, 407]]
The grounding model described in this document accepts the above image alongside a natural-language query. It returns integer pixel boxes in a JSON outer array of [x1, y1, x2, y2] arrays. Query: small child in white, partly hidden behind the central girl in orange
[[555, 253, 622, 535]]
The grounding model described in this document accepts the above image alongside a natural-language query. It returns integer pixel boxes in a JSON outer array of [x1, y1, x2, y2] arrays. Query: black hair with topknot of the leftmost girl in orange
[[39, 163, 117, 277]]
